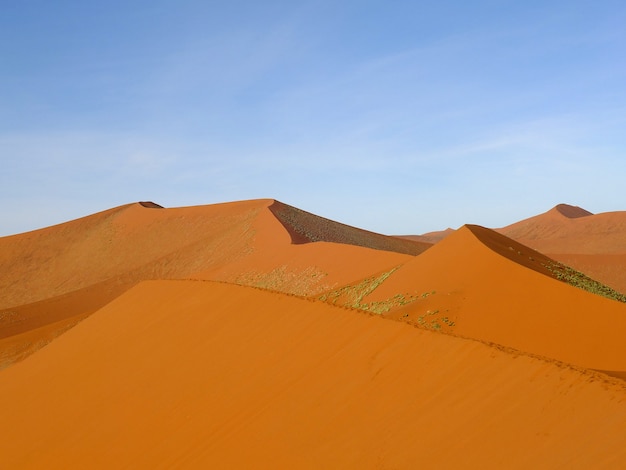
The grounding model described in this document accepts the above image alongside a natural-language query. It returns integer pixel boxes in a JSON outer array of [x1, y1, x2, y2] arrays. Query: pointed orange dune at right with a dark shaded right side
[[346, 226, 626, 371]]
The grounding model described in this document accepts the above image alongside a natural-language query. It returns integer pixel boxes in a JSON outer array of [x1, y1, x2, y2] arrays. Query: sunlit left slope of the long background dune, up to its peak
[[0, 201, 268, 308]]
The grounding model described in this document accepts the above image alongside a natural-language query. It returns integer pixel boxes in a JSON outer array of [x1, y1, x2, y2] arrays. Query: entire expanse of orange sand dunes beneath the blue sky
[[0, 199, 626, 469]]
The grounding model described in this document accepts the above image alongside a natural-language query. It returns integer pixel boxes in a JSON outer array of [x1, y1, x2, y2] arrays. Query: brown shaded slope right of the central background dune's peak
[[270, 201, 431, 255]]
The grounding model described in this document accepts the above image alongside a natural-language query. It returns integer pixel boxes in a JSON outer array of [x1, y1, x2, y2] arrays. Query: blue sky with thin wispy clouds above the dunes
[[0, 0, 626, 235]]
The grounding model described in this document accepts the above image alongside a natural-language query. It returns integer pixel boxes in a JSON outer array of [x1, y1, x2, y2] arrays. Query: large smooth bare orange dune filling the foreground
[[0, 280, 626, 469]]
